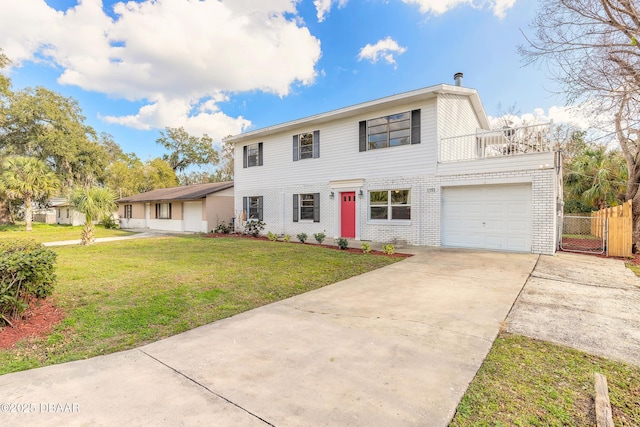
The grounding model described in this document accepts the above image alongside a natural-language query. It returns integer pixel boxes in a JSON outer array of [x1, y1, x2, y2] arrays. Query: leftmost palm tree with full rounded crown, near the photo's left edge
[[0, 156, 60, 231]]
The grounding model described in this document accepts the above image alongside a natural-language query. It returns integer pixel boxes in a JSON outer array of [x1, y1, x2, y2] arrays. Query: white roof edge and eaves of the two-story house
[[222, 84, 489, 144]]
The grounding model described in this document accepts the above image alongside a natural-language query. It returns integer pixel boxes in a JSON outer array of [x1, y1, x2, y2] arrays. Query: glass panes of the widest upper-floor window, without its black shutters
[[367, 111, 411, 150]]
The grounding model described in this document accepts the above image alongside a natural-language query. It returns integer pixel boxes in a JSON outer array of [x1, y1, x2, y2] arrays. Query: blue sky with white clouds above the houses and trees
[[0, 0, 576, 164]]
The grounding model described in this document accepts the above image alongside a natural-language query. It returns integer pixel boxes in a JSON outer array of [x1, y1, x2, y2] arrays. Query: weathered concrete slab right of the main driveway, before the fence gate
[[507, 252, 640, 366]]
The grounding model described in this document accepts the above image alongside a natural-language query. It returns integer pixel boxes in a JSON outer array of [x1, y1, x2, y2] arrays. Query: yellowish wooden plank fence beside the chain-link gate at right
[[591, 200, 633, 257]]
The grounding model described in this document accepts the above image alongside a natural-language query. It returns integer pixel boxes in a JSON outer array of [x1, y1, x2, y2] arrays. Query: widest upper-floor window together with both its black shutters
[[359, 110, 420, 151]]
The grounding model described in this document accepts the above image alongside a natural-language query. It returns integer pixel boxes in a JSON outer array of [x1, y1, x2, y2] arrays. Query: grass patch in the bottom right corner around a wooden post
[[450, 334, 640, 427]]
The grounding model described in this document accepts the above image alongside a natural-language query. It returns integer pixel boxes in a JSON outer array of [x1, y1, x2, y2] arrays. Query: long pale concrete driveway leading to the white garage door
[[0, 249, 538, 426]]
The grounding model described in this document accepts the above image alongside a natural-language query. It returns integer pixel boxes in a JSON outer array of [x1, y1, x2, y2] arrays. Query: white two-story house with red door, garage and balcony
[[225, 76, 562, 254]]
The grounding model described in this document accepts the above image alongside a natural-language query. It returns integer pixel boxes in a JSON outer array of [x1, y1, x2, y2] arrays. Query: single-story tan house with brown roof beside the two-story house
[[117, 182, 234, 233]]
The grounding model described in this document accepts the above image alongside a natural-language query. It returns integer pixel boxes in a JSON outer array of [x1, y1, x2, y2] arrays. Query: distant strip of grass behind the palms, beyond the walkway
[[0, 222, 134, 243]]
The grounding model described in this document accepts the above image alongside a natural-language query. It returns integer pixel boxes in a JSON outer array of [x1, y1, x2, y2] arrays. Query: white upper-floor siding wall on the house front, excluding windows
[[234, 99, 438, 193]]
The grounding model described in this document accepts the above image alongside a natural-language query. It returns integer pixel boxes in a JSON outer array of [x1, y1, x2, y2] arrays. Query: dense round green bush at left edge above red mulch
[[0, 239, 57, 324]]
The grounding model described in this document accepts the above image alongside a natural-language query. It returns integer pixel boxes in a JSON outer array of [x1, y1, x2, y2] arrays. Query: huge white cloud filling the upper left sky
[[0, 0, 321, 137]]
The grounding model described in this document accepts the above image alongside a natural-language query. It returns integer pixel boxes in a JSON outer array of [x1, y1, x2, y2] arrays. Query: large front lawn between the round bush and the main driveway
[[0, 236, 398, 374]]
